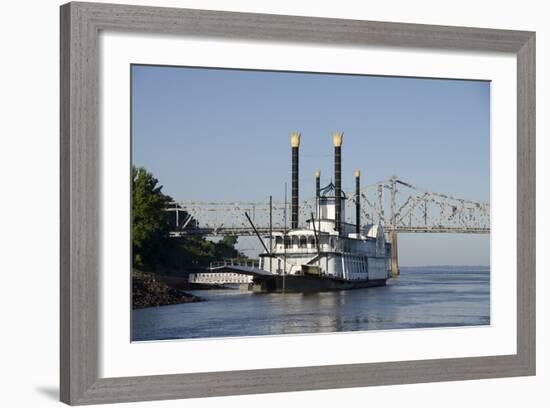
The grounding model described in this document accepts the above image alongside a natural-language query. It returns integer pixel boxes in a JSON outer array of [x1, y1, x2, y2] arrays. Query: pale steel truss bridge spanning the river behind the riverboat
[[166, 177, 490, 237]]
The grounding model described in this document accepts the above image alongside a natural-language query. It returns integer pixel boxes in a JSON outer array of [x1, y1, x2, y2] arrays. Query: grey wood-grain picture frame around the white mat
[[60, 3, 535, 405]]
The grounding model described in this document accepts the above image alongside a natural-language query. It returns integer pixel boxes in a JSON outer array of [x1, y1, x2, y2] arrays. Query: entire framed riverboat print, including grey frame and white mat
[[61, 3, 535, 404]]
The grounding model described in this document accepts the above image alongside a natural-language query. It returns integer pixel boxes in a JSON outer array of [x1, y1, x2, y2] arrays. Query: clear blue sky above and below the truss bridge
[[132, 65, 490, 265]]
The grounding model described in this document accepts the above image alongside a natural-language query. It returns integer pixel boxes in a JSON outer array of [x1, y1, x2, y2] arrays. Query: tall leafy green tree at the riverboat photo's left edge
[[132, 166, 172, 268]]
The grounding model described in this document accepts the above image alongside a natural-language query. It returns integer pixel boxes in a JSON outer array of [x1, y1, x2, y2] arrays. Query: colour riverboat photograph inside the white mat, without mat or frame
[[130, 64, 491, 341]]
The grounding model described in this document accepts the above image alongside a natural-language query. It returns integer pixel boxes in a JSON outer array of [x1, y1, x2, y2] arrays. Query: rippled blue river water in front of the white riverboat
[[132, 267, 490, 341]]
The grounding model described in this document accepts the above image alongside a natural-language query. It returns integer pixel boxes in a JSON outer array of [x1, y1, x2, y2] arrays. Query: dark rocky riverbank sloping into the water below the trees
[[132, 270, 204, 309]]
